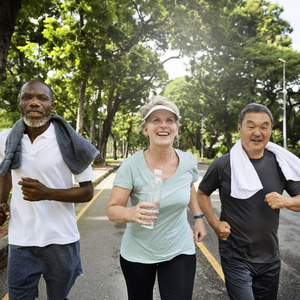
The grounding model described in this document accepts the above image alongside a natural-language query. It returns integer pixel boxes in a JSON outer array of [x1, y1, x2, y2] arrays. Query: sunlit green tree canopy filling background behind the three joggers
[[0, 0, 300, 159]]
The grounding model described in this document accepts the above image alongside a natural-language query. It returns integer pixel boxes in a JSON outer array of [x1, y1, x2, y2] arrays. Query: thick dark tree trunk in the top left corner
[[0, 0, 22, 85]]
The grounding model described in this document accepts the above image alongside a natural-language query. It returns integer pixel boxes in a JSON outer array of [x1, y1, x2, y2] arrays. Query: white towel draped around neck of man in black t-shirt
[[230, 140, 300, 199]]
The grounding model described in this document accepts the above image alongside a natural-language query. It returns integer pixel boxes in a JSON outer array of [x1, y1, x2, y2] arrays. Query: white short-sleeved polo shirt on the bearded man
[[0, 123, 95, 247]]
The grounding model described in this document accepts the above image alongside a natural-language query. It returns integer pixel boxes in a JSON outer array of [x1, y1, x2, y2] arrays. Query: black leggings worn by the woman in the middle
[[120, 254, 196, 300]]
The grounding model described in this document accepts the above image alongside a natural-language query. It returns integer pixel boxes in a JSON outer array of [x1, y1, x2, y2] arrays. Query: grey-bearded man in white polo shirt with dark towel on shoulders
[[0, 80, 99, 300]]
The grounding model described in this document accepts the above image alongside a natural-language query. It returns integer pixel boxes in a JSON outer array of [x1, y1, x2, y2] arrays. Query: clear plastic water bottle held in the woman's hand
[[142, 169, 163, 229]]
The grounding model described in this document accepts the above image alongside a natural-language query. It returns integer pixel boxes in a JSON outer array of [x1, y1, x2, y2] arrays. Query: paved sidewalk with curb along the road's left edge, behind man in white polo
[[0, 161, 121, 270]]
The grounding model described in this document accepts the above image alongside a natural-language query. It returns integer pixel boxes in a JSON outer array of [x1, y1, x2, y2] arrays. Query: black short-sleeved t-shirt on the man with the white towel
[[199, 149, 300, 263]]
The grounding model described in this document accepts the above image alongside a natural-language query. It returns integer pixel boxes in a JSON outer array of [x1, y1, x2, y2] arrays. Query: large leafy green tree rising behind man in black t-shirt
[[183, 0, 299, 150]]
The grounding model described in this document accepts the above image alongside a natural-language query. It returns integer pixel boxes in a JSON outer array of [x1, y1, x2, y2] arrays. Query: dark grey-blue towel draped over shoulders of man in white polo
[[0, 114, 99, 175]]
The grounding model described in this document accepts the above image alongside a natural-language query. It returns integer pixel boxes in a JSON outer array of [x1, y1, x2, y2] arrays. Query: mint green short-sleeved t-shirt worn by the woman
[[114, 149, 199, 263]]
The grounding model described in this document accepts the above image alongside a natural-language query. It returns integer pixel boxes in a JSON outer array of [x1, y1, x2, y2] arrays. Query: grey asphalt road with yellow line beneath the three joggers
[[0, 165, 300, 300]]
